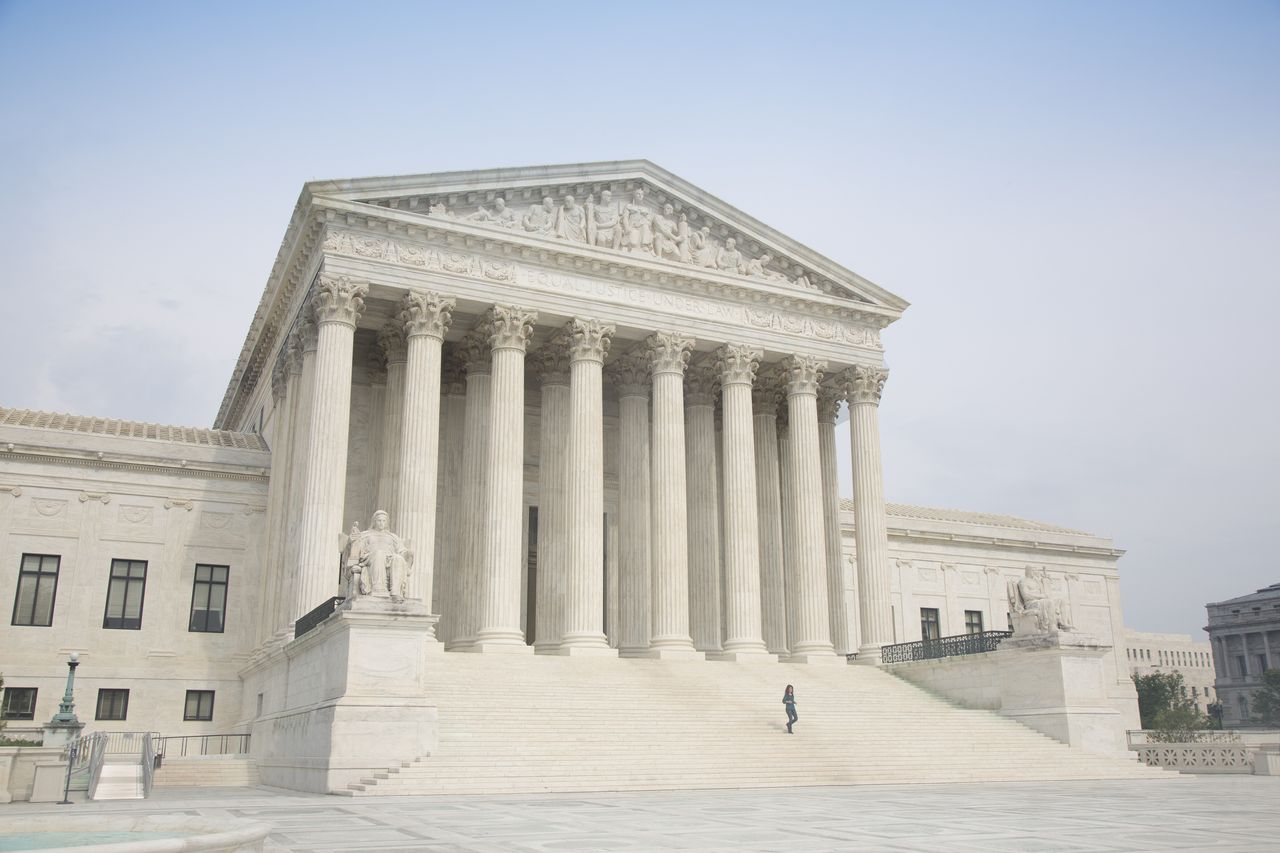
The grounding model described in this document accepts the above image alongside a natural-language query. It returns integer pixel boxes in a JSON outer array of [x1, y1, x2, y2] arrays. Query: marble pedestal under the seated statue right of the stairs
[[991, 631, 1133, 757]]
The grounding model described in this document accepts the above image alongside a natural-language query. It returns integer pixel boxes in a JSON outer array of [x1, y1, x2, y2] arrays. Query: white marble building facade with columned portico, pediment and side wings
[[0, 161, 1132, 734]]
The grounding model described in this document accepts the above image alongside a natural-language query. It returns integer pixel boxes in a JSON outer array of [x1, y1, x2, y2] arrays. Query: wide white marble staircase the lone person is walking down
[[338, 653, 1171, 797]]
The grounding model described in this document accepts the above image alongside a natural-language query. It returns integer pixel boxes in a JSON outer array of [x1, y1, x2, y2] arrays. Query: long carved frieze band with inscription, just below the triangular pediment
[[324, 229, 883, 351]]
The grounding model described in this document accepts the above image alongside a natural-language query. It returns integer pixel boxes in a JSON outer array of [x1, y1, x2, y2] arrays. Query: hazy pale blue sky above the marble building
[[0, 0, 1280, 637]]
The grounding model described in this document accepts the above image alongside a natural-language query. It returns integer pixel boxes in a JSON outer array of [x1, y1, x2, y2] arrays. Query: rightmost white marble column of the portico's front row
[[842, 365, 893, 665]]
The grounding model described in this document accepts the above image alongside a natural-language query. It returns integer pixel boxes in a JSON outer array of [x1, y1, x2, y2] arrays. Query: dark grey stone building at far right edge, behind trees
[[1204, 584, 1280, 727]]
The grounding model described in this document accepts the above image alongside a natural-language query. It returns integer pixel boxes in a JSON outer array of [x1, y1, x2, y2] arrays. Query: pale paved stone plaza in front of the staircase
[[0, 776, 1280, 853]]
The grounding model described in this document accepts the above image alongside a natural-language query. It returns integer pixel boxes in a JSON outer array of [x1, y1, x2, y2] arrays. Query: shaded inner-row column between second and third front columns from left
[[447, 323, 493, 649]]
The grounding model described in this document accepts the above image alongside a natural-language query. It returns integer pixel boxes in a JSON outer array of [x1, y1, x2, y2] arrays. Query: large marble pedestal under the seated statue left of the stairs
[[243, 596, 440, 793]]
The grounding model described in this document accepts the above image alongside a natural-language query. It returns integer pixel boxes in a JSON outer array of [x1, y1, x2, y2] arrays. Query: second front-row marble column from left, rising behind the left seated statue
[[392, 291, 454, 607]]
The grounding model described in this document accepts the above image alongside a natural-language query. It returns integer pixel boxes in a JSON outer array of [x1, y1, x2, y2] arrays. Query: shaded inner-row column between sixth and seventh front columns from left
[[752, 388, 787, 654]]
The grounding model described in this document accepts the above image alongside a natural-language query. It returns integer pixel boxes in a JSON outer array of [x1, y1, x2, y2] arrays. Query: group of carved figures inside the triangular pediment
[[429, 188, 818, 289]]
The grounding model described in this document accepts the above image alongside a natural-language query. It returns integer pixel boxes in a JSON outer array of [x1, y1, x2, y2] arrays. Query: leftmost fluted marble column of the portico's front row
[[293, 273, 369, 619]]
